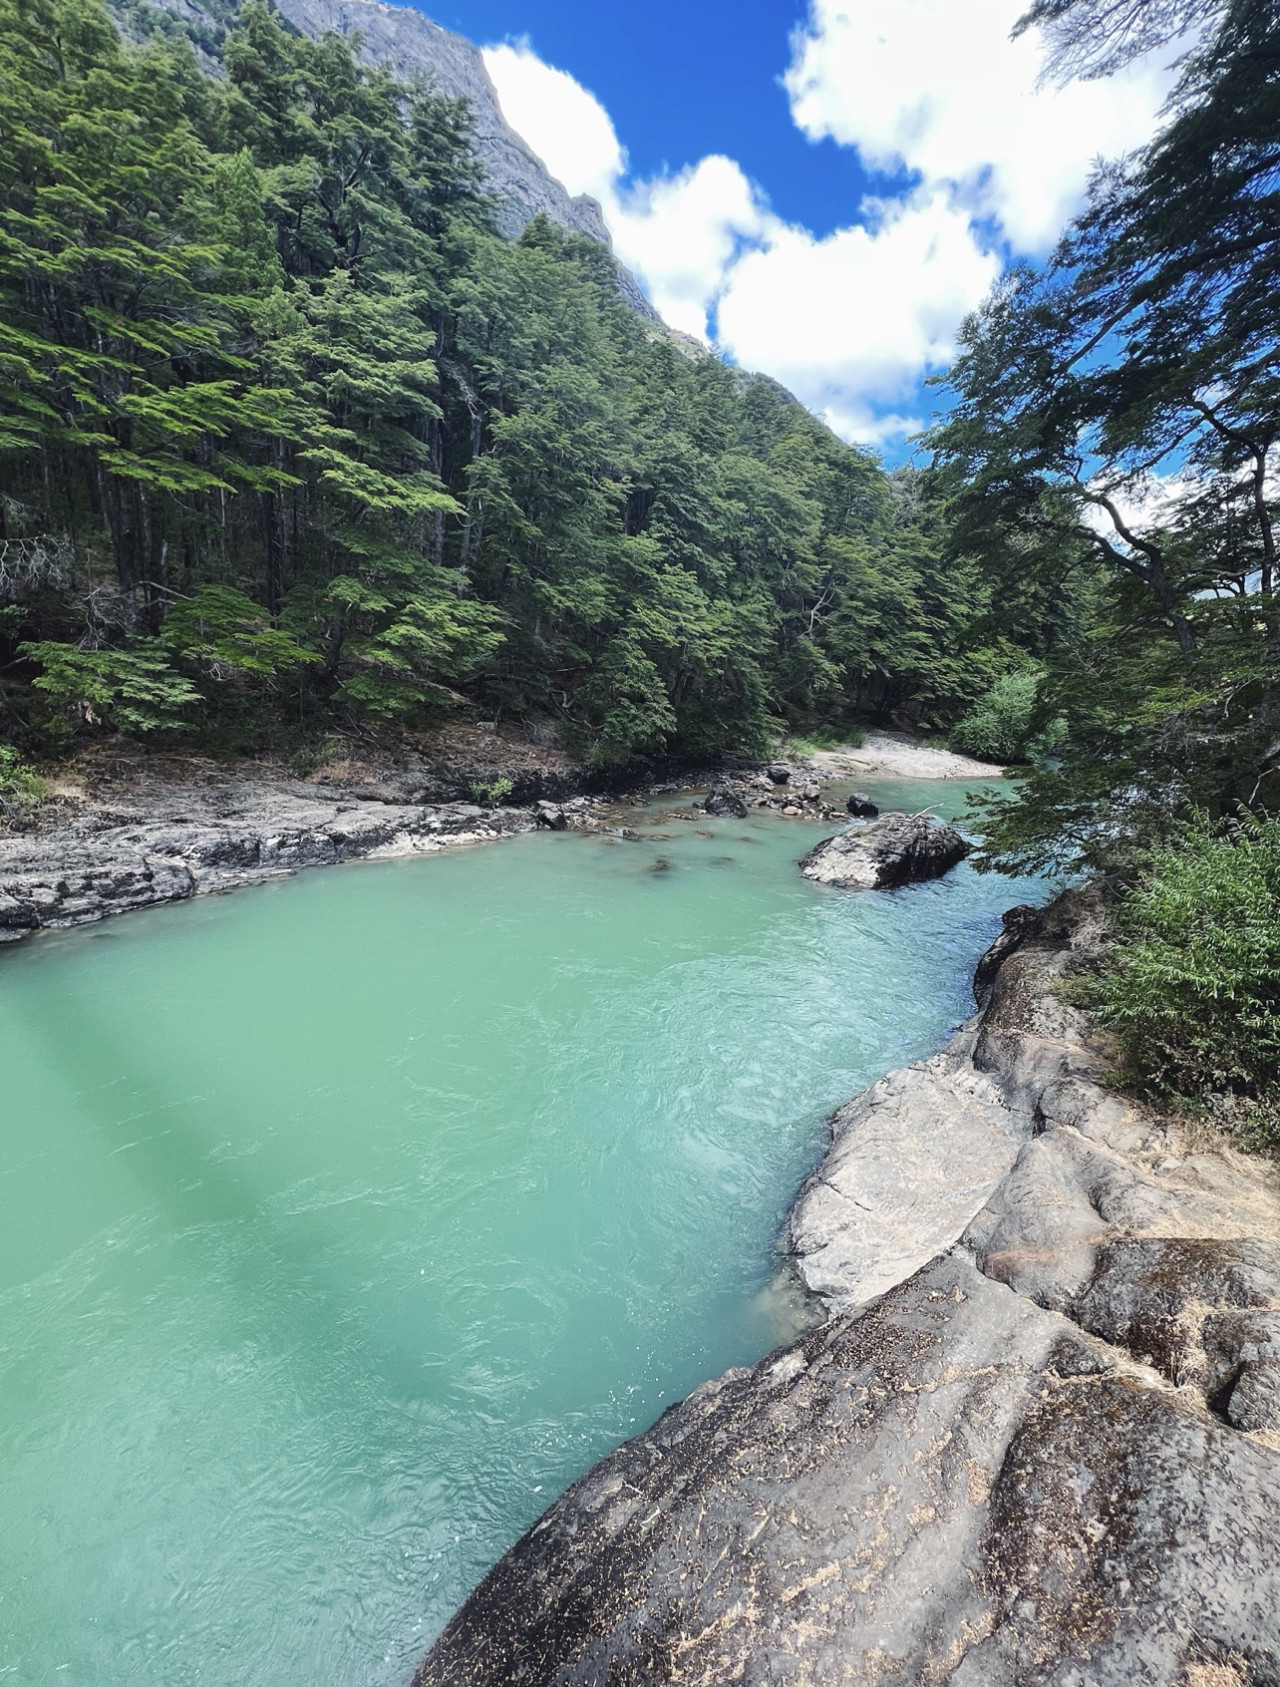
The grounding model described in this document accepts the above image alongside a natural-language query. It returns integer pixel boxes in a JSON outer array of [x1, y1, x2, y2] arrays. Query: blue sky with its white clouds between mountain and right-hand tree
[[422, 0, 1167, 459]]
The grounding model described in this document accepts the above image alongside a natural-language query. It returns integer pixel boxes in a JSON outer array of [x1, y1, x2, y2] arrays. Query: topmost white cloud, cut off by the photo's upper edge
[[784, 0, 1169, 253]]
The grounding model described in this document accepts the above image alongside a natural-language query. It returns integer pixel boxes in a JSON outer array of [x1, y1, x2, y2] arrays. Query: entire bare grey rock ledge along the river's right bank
[[417, 897, 1280, 1687]]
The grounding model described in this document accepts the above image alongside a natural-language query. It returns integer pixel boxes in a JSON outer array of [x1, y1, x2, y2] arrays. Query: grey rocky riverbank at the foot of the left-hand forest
[[0, 727, 992, 945]]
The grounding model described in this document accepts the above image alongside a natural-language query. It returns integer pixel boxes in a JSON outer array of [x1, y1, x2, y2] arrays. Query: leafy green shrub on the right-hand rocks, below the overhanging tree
[[1089, 817, 1280, 1140]]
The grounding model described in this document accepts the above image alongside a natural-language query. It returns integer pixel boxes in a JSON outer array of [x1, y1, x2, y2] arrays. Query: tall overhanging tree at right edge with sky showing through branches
[[933, 0, 1280, 872]]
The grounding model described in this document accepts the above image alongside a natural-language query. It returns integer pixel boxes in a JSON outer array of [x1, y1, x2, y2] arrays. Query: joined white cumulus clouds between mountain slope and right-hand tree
[[484, 0, 1167, 444]]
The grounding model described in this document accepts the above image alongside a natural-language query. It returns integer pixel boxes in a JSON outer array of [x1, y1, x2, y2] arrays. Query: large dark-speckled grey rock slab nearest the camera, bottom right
[[417, 1259, 1280, 1687]]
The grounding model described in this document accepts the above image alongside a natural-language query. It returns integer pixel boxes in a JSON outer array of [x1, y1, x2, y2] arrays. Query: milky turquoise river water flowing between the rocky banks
[[0, 781, 1029, 1687]]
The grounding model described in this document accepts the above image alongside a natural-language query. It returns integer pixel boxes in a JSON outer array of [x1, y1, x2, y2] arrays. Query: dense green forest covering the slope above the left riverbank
[[0, 0, 1069, 763]]
